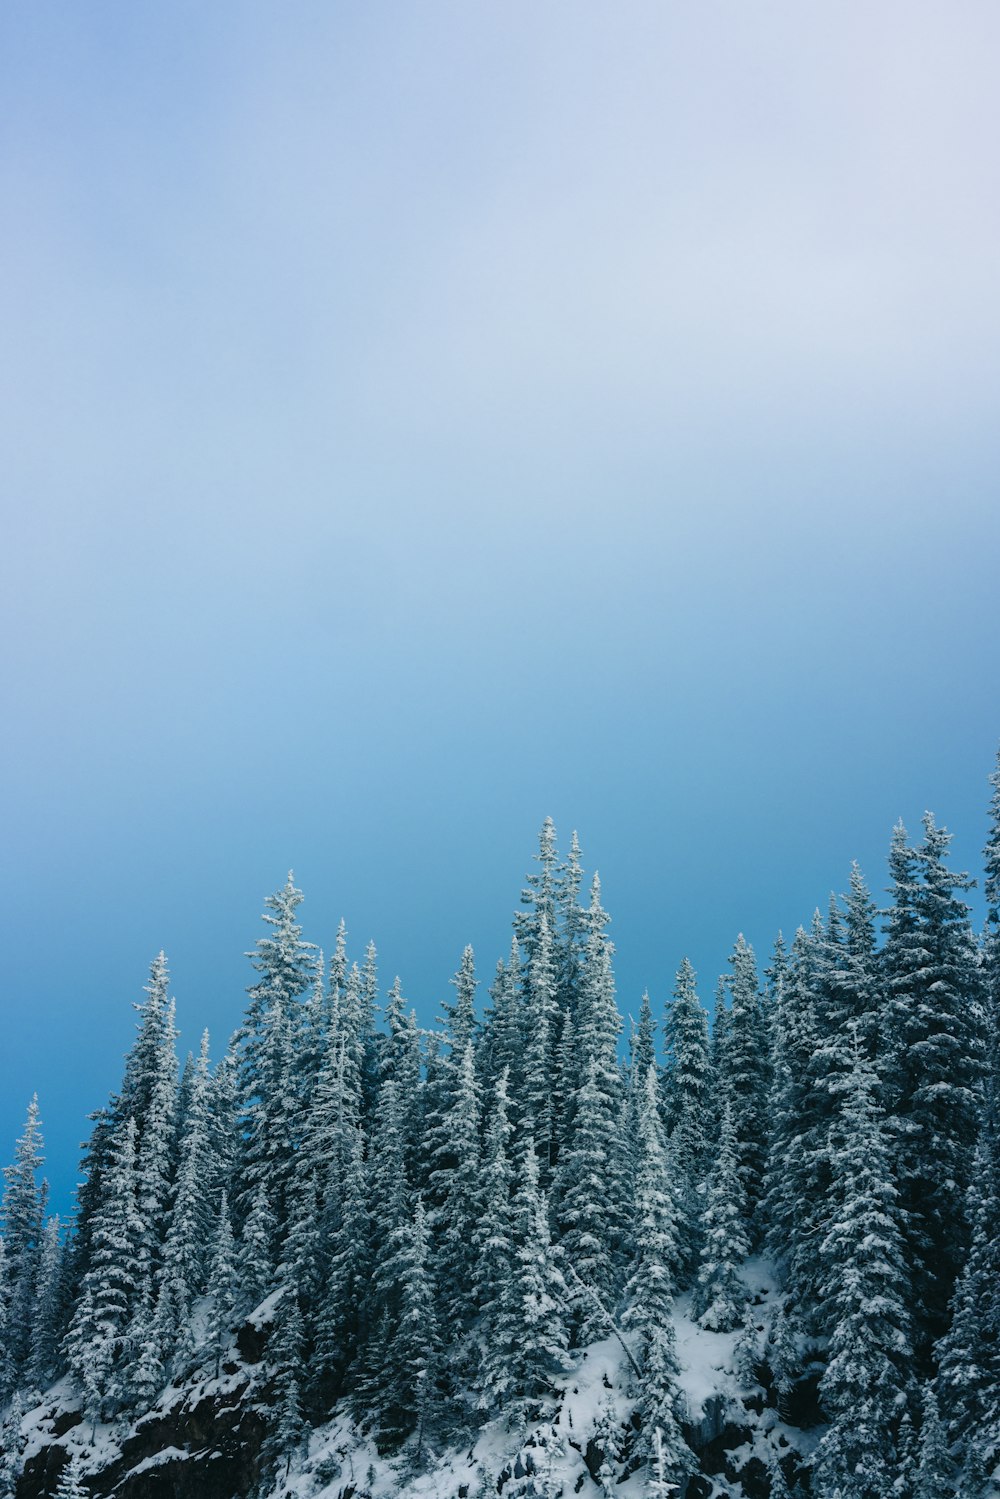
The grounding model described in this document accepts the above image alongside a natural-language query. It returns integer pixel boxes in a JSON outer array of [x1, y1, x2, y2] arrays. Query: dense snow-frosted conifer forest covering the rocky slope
[[0, 763, 1000, 1499]]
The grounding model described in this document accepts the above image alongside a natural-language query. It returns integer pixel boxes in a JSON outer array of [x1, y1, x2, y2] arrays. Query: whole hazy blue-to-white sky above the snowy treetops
[[0, 0, 1000, 1207]]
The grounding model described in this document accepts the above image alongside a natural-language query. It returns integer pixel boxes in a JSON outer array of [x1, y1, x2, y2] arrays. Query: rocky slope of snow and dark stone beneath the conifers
[[5, 1259, 810, 1499]]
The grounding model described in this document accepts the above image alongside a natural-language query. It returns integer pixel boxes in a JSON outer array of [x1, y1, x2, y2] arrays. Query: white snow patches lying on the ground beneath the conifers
[[9, 1259, 811, 1499]]
